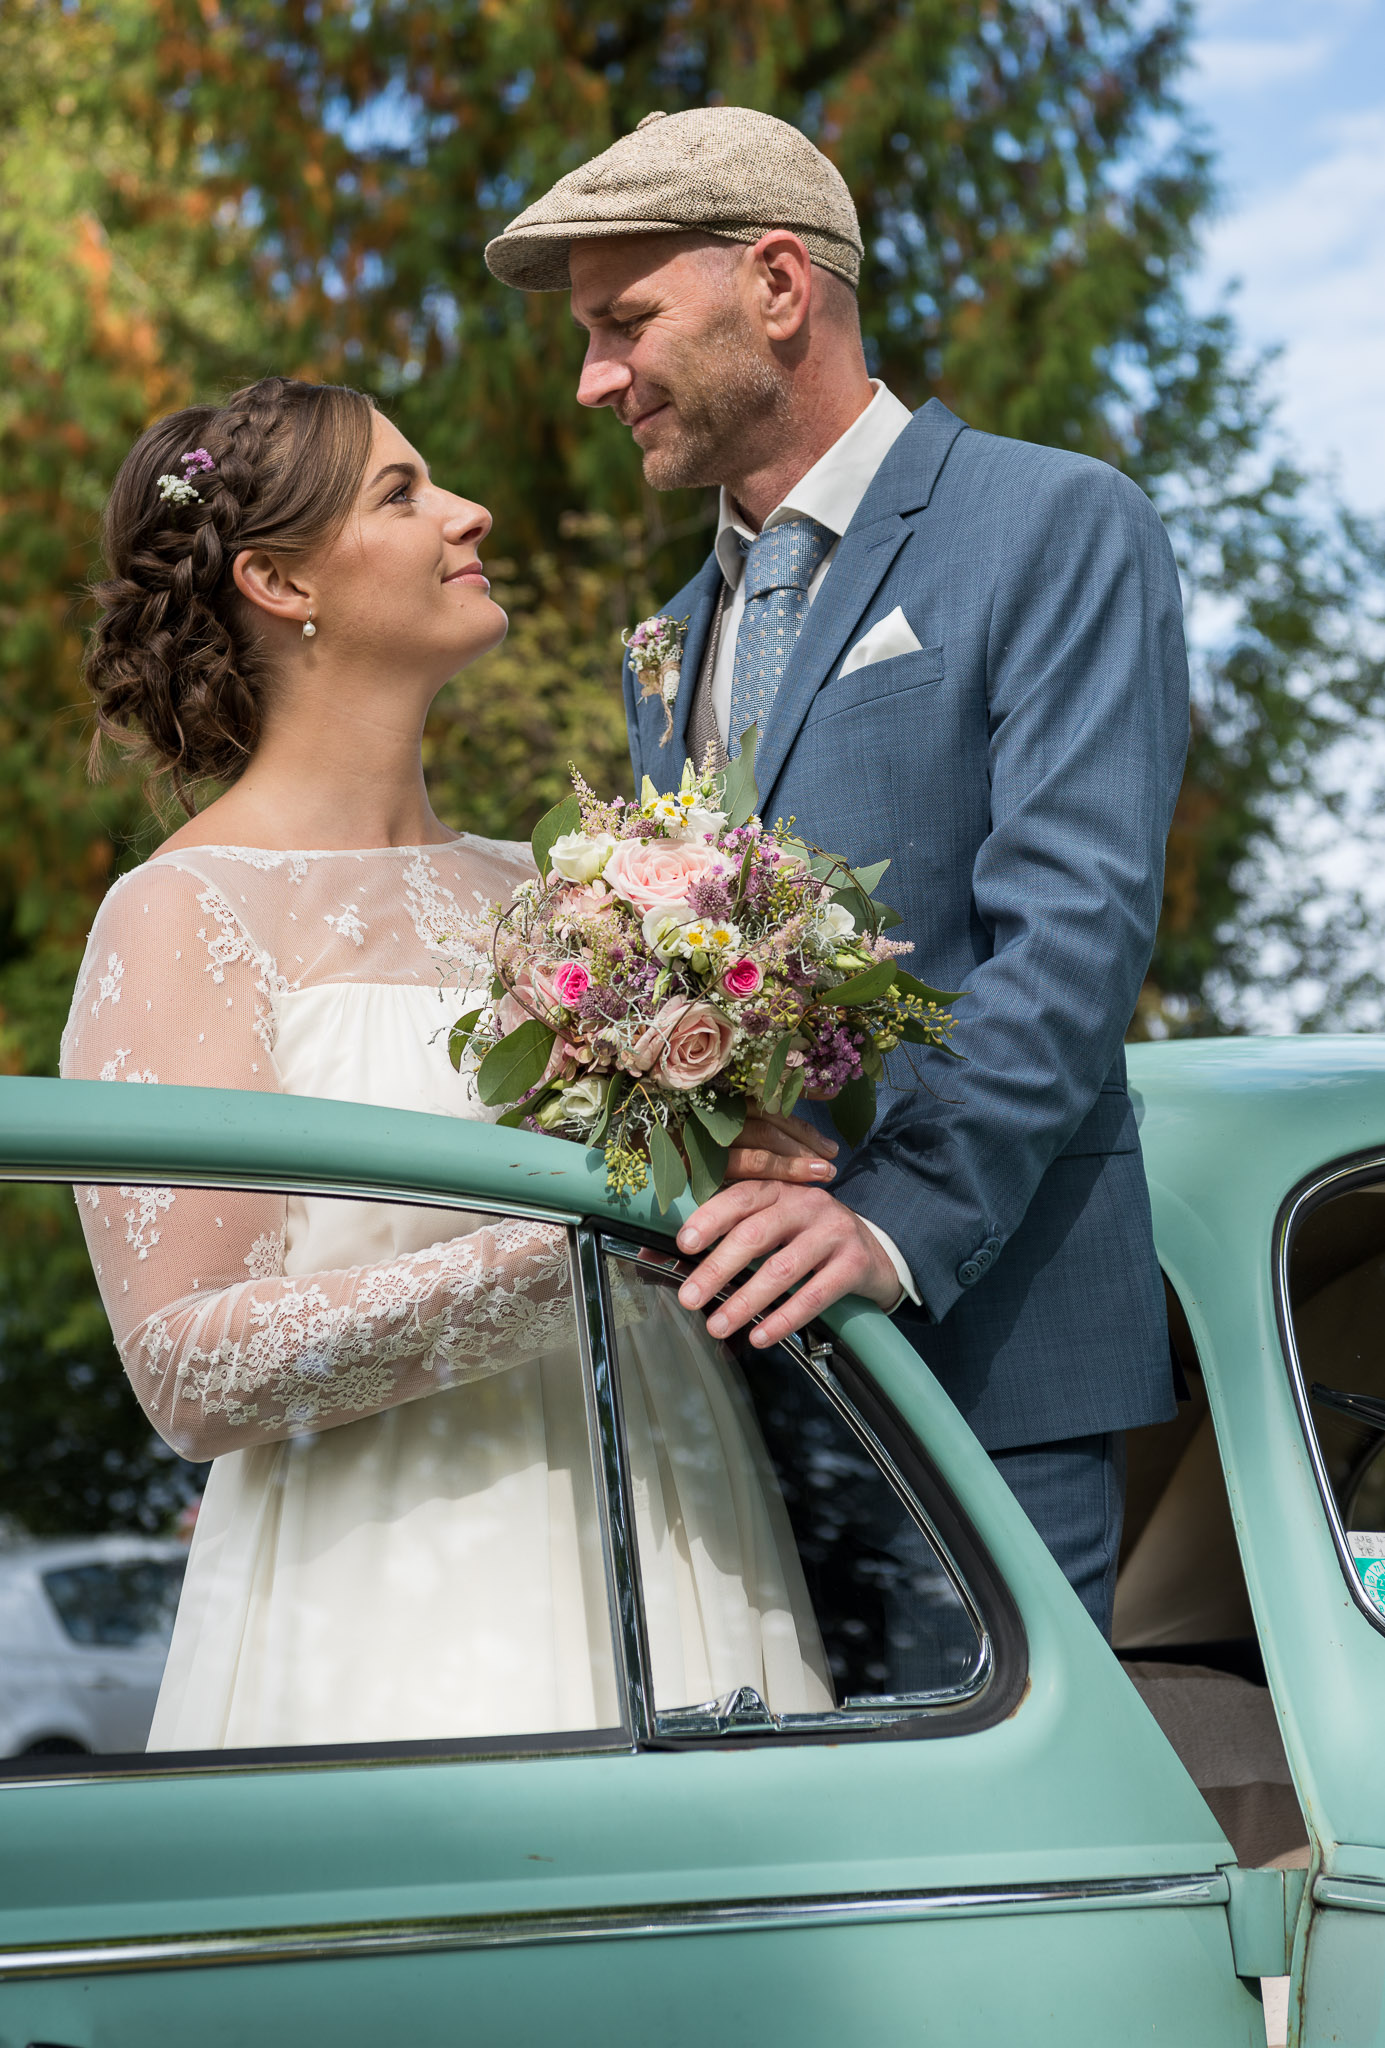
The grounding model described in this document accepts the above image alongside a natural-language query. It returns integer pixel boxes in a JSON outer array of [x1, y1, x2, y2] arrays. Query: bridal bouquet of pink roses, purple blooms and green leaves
[[449, 729, 955, 1208]]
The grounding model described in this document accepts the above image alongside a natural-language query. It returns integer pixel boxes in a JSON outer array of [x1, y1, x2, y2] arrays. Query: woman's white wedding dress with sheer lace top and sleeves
[[61, 838, 832, 1749]]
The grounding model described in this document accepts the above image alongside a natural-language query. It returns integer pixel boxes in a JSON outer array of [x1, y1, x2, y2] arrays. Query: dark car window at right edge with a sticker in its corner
[[1287, 1180, 1385, 1618]]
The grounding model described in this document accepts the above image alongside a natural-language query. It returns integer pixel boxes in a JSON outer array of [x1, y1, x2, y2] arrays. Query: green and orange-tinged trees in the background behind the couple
[[0, 0, 1385, 1526]]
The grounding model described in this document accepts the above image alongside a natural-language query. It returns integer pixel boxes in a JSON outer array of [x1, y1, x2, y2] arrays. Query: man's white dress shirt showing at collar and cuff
[[711, 377, 918, 1309]]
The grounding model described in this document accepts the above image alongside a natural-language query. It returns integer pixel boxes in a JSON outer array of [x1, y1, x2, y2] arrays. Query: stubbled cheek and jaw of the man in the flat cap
[[626, 305, 791, 492]]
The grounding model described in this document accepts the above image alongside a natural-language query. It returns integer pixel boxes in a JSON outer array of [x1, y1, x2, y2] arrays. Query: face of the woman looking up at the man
[[301, 414, 508, 684]]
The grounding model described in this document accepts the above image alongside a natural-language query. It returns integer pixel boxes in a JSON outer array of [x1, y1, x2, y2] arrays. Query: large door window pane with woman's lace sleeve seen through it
[[0, 1180, 623, 1769]]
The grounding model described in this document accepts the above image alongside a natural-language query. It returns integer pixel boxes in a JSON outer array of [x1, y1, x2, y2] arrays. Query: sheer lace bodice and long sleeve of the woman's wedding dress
[[61, 838, 572, 1458]]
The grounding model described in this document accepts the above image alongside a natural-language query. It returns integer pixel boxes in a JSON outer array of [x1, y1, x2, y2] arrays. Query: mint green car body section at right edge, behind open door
[[1133, 1038, 1385, 2048]]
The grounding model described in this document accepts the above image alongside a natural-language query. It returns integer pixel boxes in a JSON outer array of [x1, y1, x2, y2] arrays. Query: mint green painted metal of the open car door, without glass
[[0, 1081, 1258, 2048]]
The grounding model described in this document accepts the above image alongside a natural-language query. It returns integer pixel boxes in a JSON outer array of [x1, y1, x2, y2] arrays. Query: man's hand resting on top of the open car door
[[678, 1180, 899, 1348]]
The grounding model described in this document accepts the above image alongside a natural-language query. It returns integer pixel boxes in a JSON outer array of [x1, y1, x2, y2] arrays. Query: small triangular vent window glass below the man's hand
[[608, 1255, 985, 1735]]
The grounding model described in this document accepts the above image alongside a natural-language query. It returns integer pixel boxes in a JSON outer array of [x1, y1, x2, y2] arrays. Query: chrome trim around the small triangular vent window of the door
[[598, 1229, 996, 1745]]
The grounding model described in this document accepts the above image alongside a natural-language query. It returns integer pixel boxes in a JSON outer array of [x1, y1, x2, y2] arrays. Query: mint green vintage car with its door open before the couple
[[0, 1038, 1385, 2048]]
